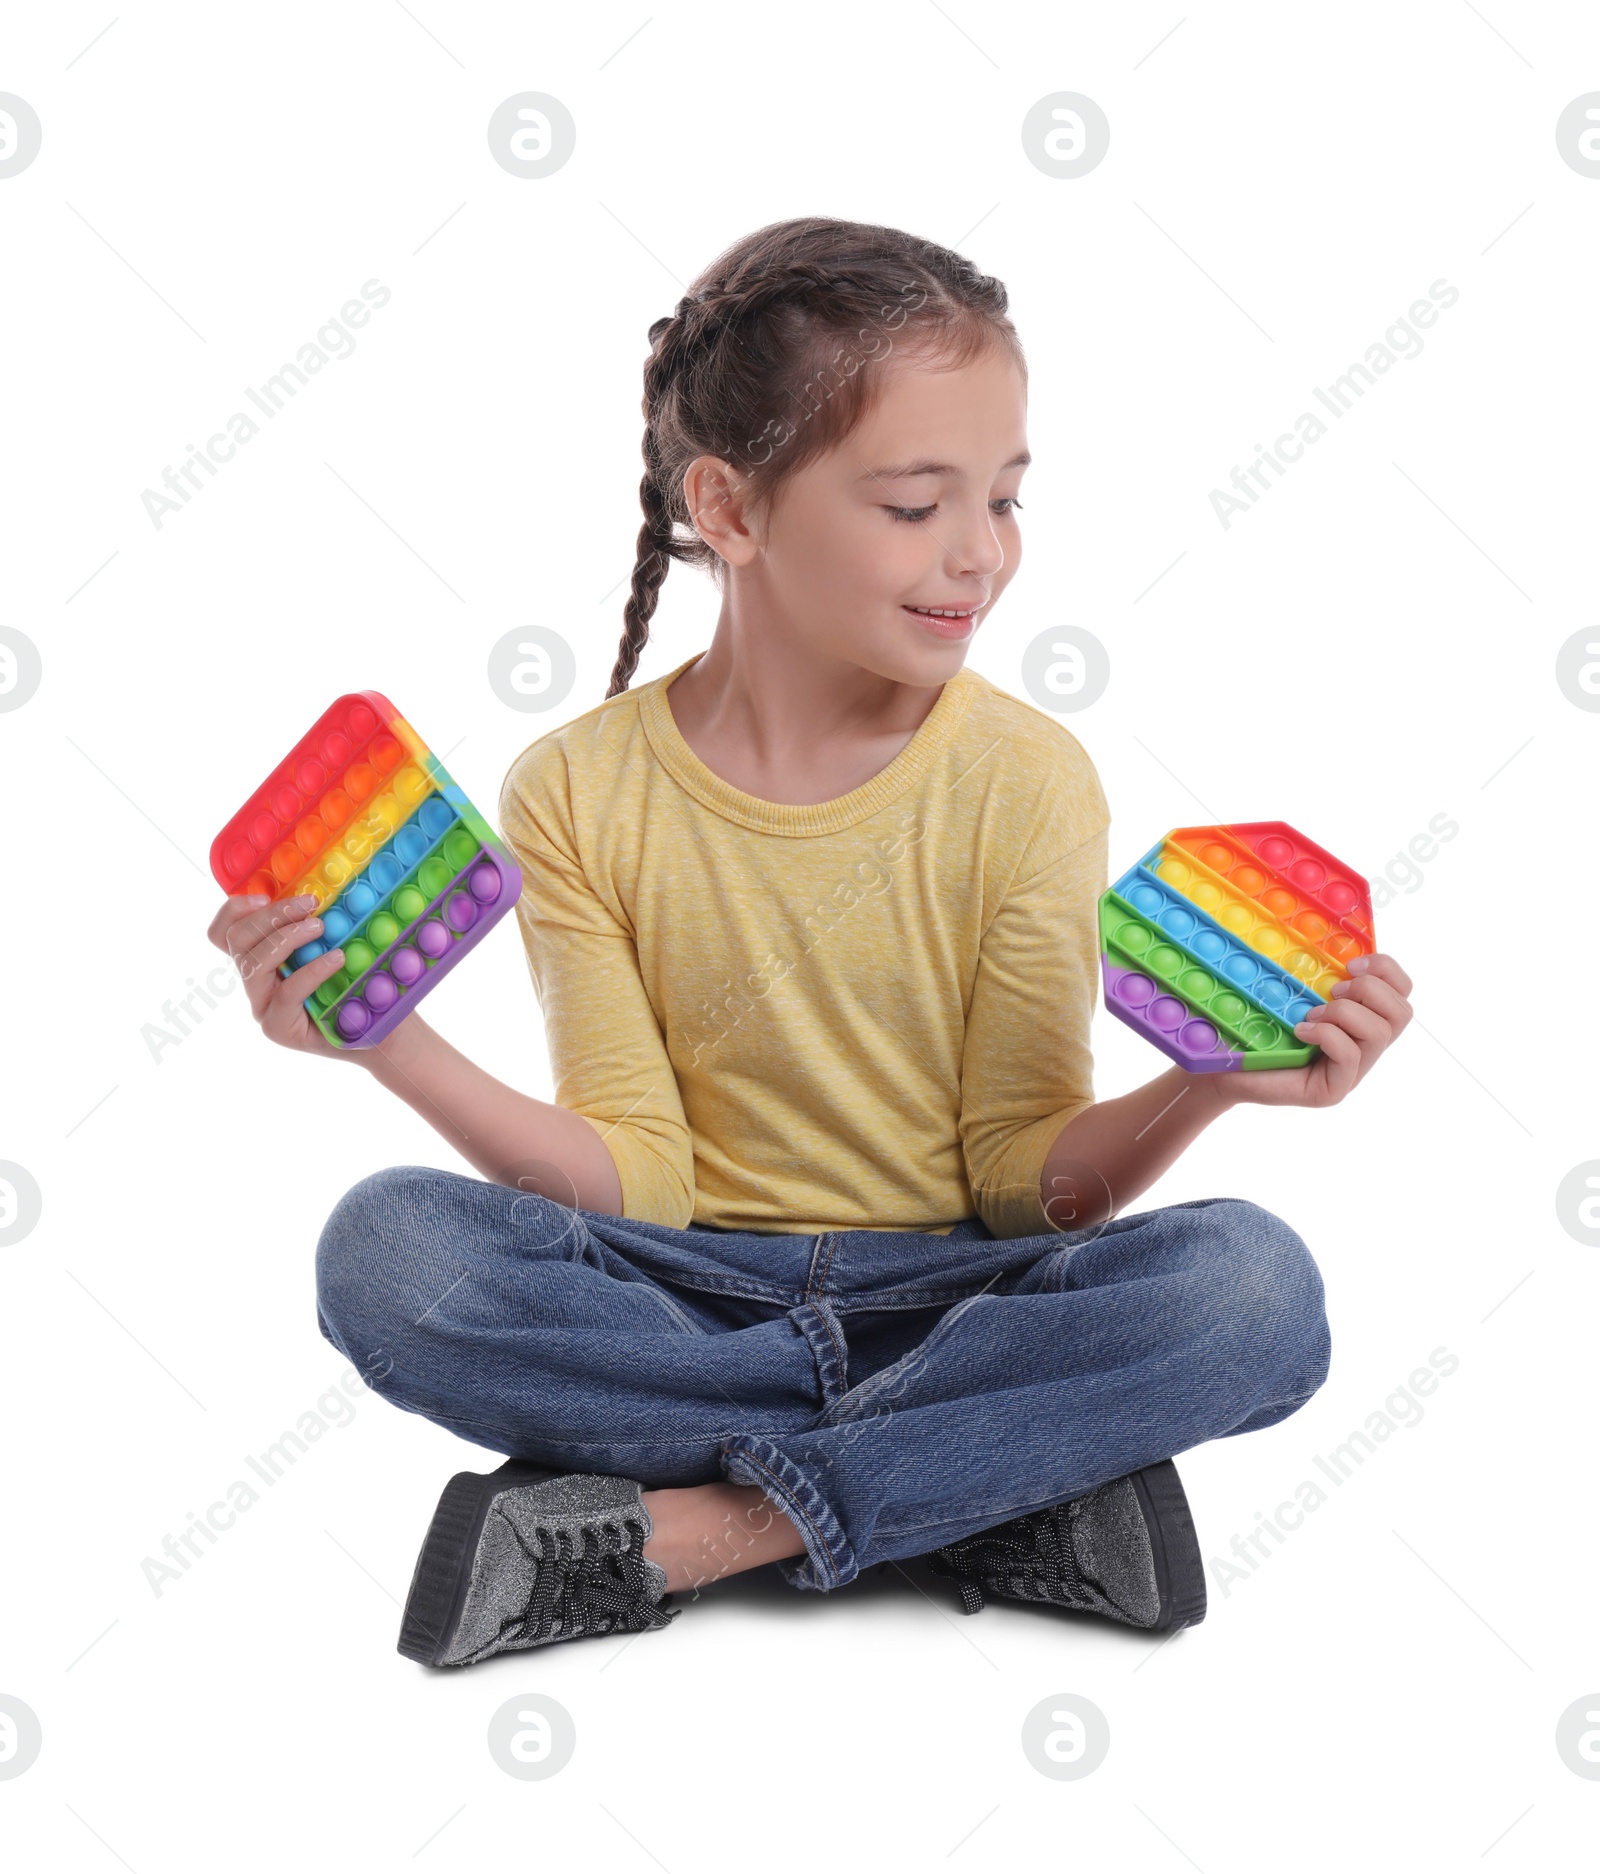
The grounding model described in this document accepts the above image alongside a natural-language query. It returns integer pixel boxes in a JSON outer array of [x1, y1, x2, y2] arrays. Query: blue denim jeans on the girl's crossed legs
[[317, 1168, 1328, 1589]]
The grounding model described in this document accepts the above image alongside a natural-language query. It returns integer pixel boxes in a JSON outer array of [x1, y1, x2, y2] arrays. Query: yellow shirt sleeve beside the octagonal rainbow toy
[[961, 757, 1109, 1237]]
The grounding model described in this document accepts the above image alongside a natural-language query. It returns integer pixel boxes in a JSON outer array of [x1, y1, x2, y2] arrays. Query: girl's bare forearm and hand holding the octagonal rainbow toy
[[1040, 952, 1411, 1229]]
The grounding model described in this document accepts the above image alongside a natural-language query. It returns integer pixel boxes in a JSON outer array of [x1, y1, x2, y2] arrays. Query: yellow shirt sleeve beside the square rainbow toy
[[500, 744, 695, 1229]]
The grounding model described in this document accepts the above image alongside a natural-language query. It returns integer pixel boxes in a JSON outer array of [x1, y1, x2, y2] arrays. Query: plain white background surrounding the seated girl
[[0, 0, 1600, 1874]]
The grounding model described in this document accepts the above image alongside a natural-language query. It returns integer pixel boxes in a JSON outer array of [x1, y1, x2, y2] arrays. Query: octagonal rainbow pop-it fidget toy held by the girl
[[1100, 821, 1375, 1074]]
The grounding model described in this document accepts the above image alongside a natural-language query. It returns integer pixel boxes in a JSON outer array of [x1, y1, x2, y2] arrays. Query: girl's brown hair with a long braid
[[605, 216, 1023, 697]]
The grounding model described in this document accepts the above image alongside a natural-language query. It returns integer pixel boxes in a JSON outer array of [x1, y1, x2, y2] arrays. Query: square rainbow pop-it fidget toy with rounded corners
[[212, 690, 523, 1048]]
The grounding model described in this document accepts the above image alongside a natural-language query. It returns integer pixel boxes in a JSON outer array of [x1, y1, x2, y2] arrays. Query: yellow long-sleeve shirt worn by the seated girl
[[500, 658, 1109, 1237]]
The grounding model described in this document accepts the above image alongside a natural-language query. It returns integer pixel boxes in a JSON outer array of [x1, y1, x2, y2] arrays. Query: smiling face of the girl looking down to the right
[[729, 345, 1029, 686]]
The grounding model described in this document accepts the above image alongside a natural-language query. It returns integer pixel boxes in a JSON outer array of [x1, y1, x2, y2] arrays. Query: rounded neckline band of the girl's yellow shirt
[[639, 650, 978, 838]]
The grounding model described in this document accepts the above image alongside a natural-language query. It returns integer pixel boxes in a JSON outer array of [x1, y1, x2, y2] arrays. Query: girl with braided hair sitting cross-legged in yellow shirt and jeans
[[212, 219, 1411, 1664]]
